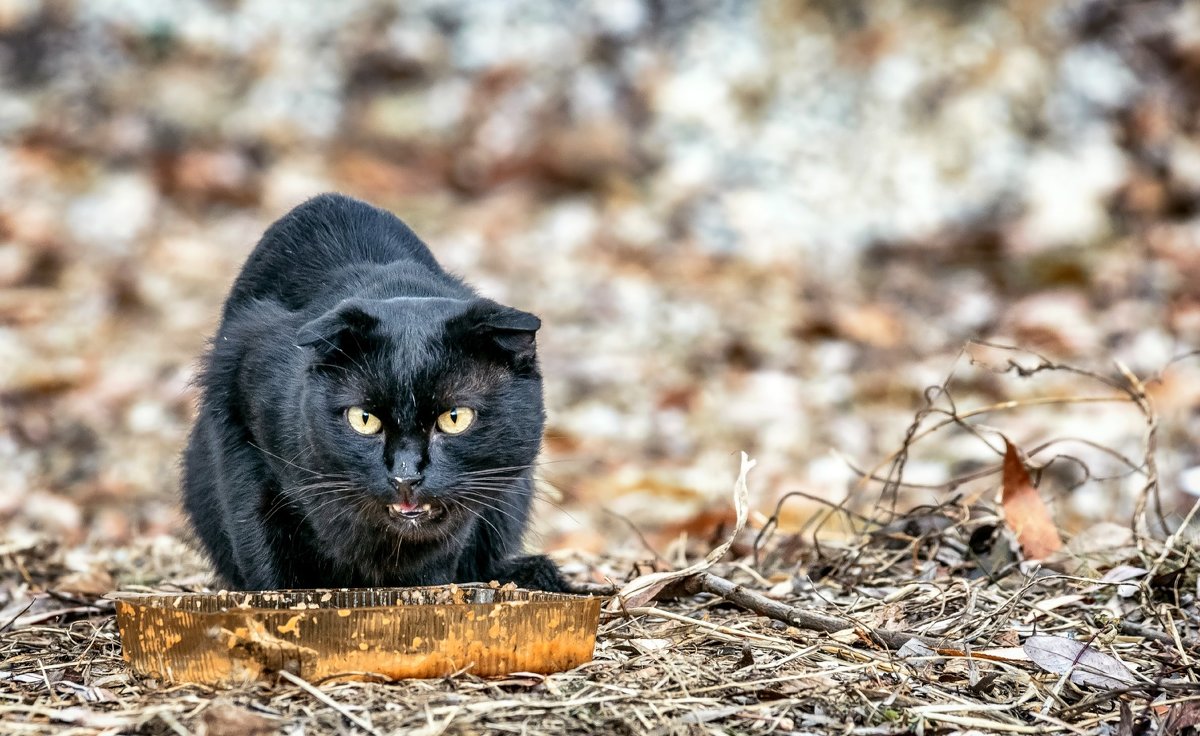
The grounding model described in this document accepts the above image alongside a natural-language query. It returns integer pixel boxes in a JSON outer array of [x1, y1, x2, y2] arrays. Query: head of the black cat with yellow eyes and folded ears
[[296, 298, 544, 543]]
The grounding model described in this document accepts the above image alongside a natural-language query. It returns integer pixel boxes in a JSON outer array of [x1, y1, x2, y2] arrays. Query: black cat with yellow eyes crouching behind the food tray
[[184, 195, 565, 591]]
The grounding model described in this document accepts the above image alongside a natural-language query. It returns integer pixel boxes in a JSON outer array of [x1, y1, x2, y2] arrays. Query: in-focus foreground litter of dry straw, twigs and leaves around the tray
[[0, 345, 1200, 736]]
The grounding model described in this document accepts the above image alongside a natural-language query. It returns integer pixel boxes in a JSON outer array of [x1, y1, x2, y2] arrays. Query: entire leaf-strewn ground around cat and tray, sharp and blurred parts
[[0, 0, 1200, 735]]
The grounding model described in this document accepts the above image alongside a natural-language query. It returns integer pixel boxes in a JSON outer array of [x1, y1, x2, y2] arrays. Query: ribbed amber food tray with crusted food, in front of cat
[[112, 585, 600, 686]]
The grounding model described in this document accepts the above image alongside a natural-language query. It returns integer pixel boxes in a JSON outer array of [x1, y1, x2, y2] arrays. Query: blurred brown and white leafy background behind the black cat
[[0, 0, 1200, 552]]
